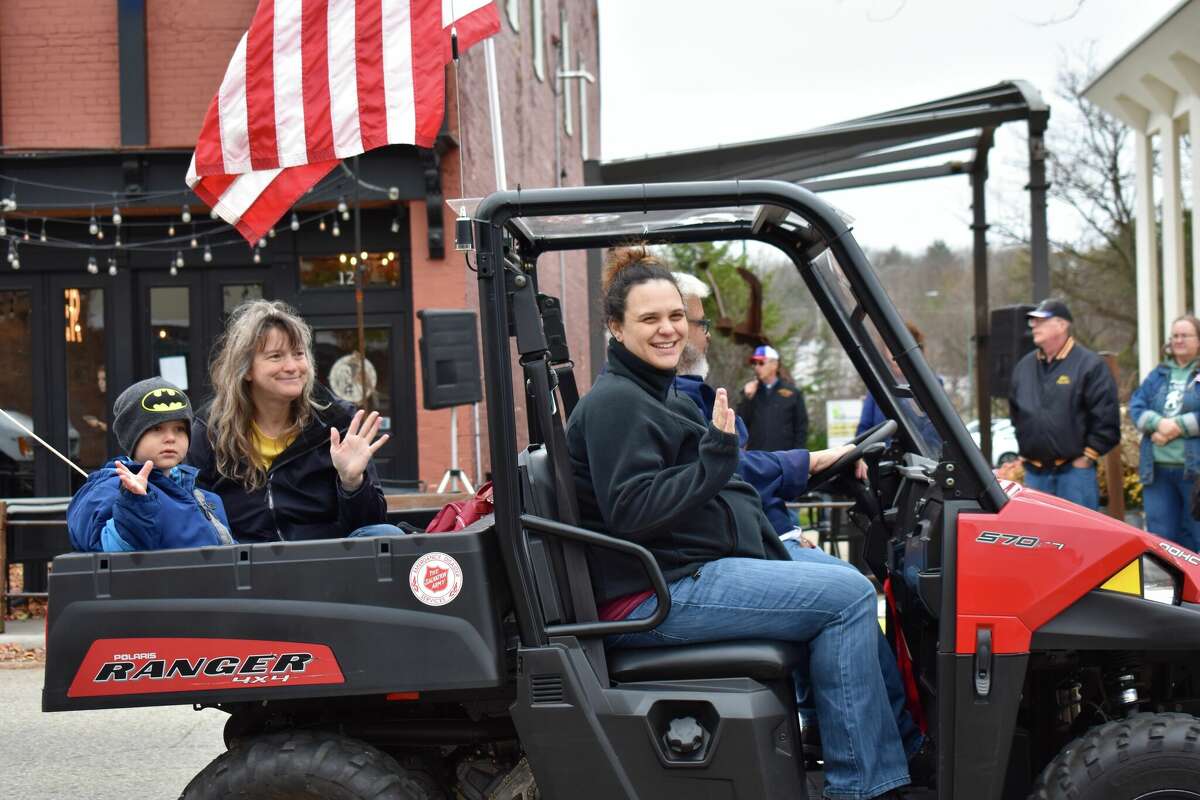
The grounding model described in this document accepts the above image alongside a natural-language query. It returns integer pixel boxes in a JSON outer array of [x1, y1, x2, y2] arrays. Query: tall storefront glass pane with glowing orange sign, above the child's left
[[62, 289, 112, 489]]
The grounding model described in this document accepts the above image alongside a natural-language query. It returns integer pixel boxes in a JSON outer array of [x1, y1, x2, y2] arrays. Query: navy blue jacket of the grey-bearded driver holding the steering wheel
[[674, 375, 809, 534]]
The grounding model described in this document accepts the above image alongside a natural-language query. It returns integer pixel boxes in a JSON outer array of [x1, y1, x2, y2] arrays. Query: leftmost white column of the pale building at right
[[1133, 130, 1163, 380]]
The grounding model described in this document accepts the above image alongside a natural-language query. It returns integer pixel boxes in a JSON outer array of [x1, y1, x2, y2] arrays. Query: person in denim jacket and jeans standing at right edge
[[1129, 314, 1200, 551]]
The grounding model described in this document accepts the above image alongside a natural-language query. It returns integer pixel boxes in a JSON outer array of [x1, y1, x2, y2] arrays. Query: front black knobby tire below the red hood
[[1030, 714, 1200, 800]]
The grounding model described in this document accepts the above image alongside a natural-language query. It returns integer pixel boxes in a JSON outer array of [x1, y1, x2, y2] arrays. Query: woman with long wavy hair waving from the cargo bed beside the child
[[188, 300, 403, 542]]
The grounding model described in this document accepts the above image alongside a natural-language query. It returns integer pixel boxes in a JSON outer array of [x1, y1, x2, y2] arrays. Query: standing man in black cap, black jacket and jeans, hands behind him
[[1008, 300, 1121, 510]]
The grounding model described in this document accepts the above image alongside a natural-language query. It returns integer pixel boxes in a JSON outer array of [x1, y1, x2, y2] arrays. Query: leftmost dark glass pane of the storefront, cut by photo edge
[[0, 290, 38, 498]]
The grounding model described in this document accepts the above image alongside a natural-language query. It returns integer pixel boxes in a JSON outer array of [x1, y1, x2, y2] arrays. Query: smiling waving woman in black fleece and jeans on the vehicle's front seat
[[566, 247, 908, 800]]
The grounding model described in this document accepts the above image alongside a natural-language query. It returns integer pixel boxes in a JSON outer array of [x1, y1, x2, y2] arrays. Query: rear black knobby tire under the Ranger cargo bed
[[180, 730, 439, 800]]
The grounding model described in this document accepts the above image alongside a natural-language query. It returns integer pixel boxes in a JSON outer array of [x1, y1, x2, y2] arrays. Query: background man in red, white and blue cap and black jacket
[[738, 345, 809, 450]]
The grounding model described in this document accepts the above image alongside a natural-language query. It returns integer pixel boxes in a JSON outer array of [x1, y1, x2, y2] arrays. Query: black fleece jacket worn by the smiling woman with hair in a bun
[[566, 339, 788, 602]]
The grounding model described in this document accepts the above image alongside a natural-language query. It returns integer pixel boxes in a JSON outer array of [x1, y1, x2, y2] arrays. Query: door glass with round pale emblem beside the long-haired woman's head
[[313, 327, 392, 422]]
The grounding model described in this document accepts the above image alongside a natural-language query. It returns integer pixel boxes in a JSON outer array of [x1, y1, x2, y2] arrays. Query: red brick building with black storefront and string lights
[[0, 0, 599, 497]]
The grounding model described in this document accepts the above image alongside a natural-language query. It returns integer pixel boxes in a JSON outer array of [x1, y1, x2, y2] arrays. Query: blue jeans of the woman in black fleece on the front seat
[[608, 546, 908, 800]]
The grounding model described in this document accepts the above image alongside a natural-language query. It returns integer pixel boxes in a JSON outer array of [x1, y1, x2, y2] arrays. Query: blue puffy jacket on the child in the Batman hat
[[67, 458, 233, 552]]
